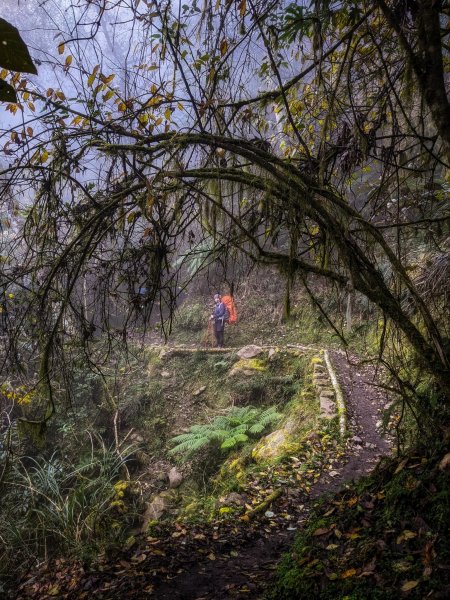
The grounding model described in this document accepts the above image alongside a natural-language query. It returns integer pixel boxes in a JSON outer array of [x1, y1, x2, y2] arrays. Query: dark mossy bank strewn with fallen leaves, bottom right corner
[[270, 448, 450, 600]]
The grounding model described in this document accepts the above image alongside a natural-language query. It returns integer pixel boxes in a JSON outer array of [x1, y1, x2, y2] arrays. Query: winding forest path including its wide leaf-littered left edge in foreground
[[17, 351, 391, 600]]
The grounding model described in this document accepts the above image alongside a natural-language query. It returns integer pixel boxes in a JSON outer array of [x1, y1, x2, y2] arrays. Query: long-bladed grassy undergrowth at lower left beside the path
[[0, 432, 137, 588]]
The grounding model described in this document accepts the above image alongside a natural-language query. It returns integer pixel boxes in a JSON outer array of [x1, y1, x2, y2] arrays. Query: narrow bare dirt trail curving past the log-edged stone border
[[147, 352, 391, 600]]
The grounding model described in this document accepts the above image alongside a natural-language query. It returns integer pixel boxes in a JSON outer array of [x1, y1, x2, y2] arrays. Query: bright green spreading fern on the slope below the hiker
[[169, 406, 282, 458]]
